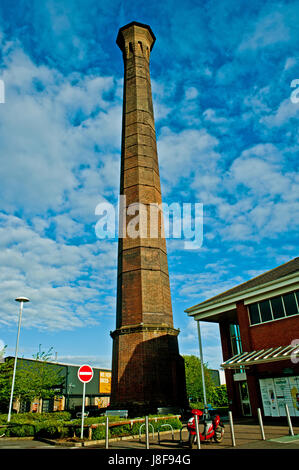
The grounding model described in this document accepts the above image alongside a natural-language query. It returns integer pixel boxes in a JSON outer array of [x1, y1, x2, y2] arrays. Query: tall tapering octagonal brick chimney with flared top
[[110, 22, 186, 416]]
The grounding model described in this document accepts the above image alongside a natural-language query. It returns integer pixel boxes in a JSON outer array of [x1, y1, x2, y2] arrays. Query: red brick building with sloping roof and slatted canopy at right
[[186, 258, 299, 418]]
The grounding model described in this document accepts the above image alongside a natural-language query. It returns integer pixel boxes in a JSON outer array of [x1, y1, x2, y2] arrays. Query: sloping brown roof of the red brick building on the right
[[185, 257, 299, 312]]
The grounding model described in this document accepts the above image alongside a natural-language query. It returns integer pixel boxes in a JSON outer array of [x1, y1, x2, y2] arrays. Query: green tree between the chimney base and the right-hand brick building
[[183, 356, 215, 403]]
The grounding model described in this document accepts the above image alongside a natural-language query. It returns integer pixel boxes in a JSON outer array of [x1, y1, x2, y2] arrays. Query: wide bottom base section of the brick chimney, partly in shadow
[[110, 330, 186, 409]]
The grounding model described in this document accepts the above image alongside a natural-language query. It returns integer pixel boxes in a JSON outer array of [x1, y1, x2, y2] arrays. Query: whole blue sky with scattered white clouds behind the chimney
[[0, 0, 299, 374]]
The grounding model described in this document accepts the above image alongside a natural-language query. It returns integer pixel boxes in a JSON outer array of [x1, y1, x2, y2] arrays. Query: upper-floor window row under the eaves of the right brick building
[[248, 291, 299, 325]]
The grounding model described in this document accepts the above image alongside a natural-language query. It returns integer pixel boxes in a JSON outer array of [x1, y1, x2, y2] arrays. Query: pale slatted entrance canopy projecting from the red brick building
[[221, 342, 299, 369]]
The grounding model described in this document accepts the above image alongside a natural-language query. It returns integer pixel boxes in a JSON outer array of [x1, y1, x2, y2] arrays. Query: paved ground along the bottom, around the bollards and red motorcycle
[[0, 423, 299, 451]]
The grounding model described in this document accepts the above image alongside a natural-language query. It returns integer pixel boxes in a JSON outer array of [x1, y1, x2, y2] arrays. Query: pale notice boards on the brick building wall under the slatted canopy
[[259, 376, 299, 417]]
